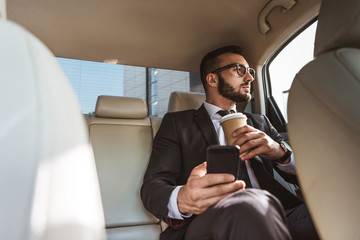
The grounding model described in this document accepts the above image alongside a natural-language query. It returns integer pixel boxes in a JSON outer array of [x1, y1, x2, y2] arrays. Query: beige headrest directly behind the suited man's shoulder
[[168, 92, 205, 112]]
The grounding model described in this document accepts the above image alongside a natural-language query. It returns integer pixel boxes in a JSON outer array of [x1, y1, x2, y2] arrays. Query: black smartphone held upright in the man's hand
[[206, 145, 240, 179]]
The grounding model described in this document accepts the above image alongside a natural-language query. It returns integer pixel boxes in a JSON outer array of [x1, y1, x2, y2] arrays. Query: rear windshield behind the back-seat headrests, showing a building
[[56, 58, 202, 117]]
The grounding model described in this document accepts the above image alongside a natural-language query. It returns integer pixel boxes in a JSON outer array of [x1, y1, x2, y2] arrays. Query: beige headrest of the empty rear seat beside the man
[[95, 96, 148, 119]]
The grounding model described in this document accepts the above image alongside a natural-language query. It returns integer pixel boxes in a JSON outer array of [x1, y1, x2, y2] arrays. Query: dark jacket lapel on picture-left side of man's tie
[[194, 104, 219, 146]]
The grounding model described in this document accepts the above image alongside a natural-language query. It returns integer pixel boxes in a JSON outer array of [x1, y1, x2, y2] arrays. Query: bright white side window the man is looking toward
[[268, 21, 317, 122]]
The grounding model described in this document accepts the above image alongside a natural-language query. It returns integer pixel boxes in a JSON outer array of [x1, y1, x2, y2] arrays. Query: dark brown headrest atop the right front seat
[[314, 0, 360, 56]]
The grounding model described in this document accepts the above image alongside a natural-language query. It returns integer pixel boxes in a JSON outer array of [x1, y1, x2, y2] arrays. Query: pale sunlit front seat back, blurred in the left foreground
[[0, 19, 104, 240]]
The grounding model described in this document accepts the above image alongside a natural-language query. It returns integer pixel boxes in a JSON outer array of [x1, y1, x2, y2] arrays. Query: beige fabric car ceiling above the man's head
[[6, 0, 321, 72]]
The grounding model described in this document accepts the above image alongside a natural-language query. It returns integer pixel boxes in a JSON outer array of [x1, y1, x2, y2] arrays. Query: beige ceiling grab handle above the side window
[[258, 0, 296, 34]]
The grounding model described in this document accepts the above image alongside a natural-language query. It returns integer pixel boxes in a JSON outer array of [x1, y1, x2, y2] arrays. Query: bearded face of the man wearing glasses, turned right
[[217, 53, 254, 102]]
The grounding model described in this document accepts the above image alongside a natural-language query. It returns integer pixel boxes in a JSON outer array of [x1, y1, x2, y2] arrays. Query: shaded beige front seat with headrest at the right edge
[[288, 0, 360, 239]]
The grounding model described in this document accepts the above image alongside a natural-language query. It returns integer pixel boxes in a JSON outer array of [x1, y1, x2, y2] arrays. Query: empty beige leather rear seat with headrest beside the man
[[89, 96, 161, 240]]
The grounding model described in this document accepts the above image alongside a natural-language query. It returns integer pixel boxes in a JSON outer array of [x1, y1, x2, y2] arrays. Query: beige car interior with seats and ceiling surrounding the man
[[0, 0, 360, 240]]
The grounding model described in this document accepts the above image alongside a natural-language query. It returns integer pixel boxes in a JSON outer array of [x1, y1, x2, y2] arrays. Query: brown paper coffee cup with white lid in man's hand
[[220, 113, 248, 157]]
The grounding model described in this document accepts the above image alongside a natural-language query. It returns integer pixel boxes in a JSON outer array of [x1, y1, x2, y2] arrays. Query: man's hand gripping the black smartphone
[[177, 162, 245, 215]]
